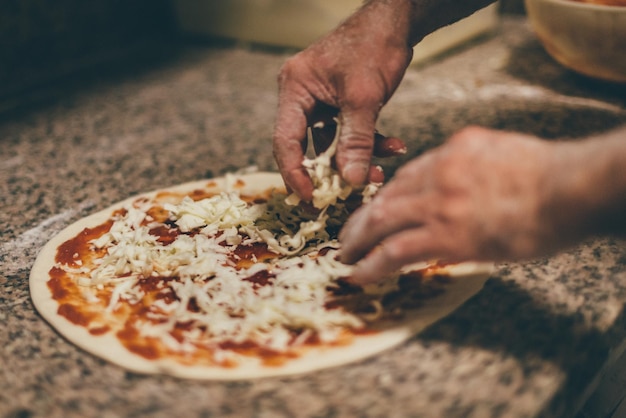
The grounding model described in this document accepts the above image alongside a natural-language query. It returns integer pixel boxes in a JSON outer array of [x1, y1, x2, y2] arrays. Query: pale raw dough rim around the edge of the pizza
[[30, 173, 493, 380]]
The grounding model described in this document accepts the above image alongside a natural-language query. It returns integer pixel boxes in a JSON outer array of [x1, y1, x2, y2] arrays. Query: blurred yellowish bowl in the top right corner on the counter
[[525, 0, 626, 82]]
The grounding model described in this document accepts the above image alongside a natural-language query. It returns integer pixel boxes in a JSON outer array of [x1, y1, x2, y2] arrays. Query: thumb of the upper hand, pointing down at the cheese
[[335, 109, 378, 186]]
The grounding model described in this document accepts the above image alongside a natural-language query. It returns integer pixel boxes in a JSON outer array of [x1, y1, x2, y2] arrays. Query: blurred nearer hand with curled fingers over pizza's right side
[[339, 128, 580, 283]]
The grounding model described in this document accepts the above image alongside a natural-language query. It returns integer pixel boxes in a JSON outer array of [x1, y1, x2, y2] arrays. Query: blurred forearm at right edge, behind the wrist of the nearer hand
[[547, 127, 626, 239]]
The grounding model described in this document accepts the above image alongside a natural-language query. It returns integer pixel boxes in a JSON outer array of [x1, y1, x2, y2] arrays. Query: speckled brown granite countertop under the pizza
[[0, 19, 626, 417]]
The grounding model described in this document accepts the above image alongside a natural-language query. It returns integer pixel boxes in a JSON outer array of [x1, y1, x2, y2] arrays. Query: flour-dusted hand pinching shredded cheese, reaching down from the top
[[273, 2, 412, 201]]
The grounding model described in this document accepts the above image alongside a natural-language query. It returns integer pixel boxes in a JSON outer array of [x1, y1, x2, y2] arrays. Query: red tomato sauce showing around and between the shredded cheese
[[48, 189, 445, 367]]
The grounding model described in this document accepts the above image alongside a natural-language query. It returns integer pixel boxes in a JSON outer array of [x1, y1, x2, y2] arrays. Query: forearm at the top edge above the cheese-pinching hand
[[363, 0, 495, 46]]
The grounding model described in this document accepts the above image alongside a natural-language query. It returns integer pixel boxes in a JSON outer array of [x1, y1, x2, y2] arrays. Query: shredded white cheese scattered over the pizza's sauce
[[61, 124, 382, 359]]
